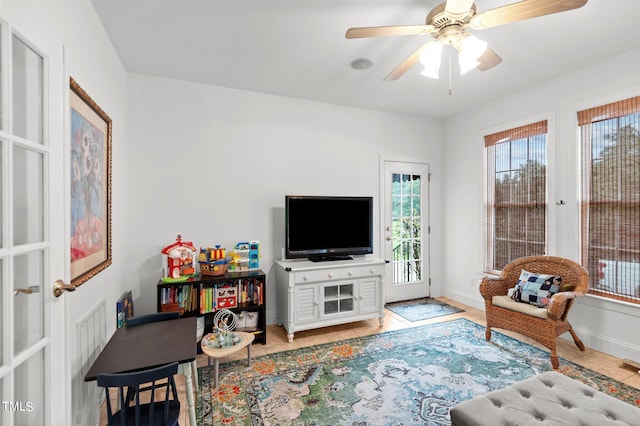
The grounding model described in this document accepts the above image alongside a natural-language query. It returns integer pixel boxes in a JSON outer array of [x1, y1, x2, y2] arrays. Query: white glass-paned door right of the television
[[381, 160, 430, 303]]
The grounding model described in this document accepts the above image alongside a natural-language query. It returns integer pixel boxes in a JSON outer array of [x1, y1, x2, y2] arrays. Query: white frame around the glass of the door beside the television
[[379, 155, 431, 303]]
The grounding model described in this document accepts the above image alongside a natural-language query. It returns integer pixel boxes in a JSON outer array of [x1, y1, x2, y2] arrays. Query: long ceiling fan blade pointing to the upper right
[[469, 0, 587, 30]]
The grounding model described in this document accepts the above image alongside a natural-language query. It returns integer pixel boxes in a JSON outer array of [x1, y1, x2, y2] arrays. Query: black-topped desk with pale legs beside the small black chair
[[84, 317, 198, 425]]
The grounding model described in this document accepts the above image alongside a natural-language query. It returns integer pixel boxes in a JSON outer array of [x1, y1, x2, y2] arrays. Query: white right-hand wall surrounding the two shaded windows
[[443, 50, 640, 360]]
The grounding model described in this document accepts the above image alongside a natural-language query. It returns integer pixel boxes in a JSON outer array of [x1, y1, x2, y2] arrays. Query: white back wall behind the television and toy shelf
[[126, 74, 442, 323]]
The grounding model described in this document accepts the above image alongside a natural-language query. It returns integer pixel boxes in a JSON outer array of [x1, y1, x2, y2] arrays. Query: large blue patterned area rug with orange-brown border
[[197, 319, 640, 426]]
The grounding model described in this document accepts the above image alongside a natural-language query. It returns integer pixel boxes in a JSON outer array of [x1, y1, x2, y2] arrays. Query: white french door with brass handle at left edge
[[0, 19, 70, 426]]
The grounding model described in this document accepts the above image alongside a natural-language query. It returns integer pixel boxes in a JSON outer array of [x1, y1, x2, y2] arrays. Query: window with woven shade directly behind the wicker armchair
[[485, 120, 547, 273]]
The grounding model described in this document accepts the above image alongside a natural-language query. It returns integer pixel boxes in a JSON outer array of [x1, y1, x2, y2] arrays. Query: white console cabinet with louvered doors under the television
[[277, 259, 385, 343]]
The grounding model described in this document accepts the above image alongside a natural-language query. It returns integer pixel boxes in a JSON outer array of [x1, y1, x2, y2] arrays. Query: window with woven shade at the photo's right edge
[[578, 97, 640, 304]]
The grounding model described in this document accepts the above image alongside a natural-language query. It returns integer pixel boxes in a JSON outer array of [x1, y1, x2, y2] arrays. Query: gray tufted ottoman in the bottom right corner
[[451, 371, 640, 426]]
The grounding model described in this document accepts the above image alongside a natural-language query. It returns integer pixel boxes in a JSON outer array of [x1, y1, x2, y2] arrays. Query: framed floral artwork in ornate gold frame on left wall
[[69, 78, 111, 286]]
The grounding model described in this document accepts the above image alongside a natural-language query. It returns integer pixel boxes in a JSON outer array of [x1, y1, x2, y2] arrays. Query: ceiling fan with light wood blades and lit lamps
[[345, 0, 587, 81]]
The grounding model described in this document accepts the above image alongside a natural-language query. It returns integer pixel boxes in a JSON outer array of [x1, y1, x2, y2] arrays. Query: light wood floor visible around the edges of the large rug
[[100, 298, 640, 425]]
